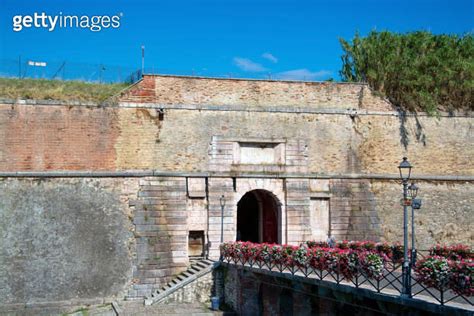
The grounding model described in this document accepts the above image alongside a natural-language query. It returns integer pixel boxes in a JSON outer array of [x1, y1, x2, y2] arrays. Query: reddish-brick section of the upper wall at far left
[[0, 105, 120, 171]]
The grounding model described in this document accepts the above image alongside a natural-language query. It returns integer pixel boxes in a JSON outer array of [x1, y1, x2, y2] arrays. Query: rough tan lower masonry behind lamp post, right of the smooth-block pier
[[370, 180, 474, 250]]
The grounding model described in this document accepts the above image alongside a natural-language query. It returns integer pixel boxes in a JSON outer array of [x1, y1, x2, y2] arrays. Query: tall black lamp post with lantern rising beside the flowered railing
[[398, 157, 412, 297]]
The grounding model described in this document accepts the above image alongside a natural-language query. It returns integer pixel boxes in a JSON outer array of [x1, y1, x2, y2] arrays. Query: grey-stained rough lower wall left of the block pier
[[0, 178, 137, 307]]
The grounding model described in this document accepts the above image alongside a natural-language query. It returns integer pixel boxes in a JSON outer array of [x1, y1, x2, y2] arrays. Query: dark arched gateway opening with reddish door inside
[[237, 189, 281, 243]]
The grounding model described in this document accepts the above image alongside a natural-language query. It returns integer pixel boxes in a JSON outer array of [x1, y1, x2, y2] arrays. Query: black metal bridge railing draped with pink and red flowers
[[221, 242, 474, 306]]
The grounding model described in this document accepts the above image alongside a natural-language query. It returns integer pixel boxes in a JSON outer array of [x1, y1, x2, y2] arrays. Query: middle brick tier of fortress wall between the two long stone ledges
[[0, 104, 474, 176]]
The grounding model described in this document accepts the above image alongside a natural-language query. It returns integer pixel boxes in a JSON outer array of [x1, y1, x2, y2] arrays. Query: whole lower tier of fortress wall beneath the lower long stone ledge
[[0, 177, 474, 311]]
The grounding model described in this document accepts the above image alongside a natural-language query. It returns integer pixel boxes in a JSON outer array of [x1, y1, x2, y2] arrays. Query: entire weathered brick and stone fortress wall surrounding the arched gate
[[0, 76, 474, 306]]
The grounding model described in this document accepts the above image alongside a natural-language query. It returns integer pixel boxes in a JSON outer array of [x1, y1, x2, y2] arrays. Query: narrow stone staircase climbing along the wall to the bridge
[[145, 258, 219, 306]]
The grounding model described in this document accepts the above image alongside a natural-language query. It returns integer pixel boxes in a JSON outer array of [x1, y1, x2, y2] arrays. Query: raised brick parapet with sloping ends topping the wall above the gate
[[120, 75, 392, 111]]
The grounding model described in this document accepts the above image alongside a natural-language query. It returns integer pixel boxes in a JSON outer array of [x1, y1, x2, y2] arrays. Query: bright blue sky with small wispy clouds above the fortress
[[0, 0, 474, 80]]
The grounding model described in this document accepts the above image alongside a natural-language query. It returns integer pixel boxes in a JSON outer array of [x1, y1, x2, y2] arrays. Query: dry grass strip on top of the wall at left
[[0, 78, 128, 102]]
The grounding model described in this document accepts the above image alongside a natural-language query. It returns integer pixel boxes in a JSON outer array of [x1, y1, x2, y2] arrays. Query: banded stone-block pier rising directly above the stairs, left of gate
[[127, 177, 188, 298]]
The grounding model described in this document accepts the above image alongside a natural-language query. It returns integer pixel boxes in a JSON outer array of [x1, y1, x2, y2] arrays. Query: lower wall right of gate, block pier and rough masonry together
[[330, 179, 474, 250]]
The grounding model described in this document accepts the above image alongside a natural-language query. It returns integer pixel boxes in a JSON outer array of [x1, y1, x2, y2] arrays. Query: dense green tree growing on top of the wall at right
[[340, 31, 474, 114]]
